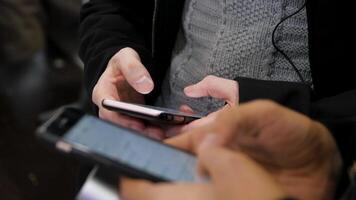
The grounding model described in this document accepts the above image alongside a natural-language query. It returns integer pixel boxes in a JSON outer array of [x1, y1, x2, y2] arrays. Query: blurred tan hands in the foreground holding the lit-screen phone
[[120, 101, 356, 200]]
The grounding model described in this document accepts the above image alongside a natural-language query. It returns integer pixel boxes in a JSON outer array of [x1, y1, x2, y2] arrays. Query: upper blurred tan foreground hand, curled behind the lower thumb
[[167, 101, 341, 199]]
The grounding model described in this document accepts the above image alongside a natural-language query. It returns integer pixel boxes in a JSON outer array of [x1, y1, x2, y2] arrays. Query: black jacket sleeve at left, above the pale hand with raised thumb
[[79, 0, 154, 96]]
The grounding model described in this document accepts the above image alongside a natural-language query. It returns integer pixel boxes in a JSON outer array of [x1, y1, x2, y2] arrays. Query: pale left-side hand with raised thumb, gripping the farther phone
[[92, 48, 163, 139]]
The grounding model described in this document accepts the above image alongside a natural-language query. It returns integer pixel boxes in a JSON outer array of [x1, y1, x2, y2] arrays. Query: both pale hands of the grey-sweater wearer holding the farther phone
[[92, 48, 238, 140]]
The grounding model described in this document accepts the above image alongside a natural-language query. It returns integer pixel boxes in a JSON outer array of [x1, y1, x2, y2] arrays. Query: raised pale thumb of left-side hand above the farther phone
[[110, 48, 154, 94]]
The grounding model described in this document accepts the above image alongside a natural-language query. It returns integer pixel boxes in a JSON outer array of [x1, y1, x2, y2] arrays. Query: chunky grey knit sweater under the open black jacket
[[157, 0, 311, 113]]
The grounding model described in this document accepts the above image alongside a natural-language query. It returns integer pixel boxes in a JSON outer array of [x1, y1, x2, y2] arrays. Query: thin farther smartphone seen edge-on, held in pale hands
[[102, 99, 203, 125]]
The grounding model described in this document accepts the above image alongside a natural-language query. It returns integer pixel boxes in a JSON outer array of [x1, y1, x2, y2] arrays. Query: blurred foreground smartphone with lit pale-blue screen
[[37, 108, 197, 182]]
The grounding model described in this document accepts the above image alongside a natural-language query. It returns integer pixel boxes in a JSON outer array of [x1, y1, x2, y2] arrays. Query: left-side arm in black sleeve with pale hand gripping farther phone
[[79, 0, 163, 138]]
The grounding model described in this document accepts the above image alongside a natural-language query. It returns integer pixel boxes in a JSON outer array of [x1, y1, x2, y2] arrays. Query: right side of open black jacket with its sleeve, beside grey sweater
[[236, 0, 356, 196]]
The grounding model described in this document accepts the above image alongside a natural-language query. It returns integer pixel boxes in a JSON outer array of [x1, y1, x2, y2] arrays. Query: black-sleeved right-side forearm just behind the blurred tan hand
[[237, 78, 356, 196]]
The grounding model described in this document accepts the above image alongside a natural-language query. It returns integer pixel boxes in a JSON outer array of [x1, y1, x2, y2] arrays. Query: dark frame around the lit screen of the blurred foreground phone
[[37, 108, 195, 182]]
